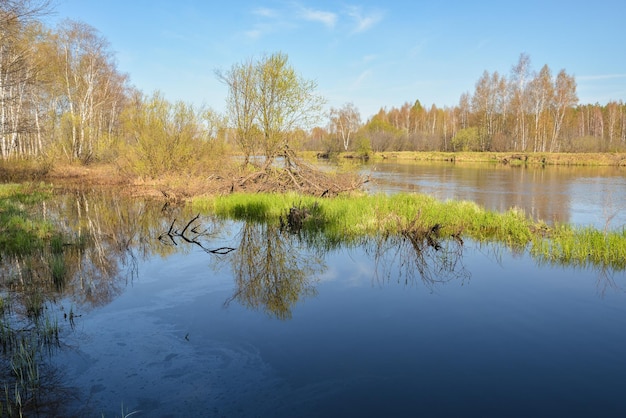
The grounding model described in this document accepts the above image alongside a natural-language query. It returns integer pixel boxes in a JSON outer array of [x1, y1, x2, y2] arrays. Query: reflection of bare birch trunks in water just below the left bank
[[45, 191, 173, 309]]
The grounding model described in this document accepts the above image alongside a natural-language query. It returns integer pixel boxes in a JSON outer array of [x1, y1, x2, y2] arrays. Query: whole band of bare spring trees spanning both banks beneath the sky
[[0, 0, 626, 176]]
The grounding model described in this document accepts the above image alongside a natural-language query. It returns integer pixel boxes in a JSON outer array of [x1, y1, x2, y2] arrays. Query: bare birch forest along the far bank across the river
[[309, 54, 626, 152]]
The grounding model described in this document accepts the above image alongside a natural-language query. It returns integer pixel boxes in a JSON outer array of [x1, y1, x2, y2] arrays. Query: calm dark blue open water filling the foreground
[[55, 224, 626, 417]]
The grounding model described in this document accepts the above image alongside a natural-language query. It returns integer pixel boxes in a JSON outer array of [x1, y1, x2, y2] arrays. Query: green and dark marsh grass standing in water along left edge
[[0, 184, 64, 416]]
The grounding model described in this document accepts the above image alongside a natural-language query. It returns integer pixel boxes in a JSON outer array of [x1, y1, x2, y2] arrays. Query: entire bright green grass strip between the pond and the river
[[194, 194, 626, 270]]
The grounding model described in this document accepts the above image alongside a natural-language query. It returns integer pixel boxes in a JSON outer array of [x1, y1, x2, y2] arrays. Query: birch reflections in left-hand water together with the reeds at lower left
[[0, 191, 183, 416]]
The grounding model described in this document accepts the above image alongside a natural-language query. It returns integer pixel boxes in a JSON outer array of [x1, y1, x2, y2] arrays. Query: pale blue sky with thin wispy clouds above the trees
[[46, 0, 626, 121]]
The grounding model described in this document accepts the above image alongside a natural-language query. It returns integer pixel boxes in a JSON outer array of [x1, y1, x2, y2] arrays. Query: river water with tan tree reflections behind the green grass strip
[[363, 162, 626, 229]]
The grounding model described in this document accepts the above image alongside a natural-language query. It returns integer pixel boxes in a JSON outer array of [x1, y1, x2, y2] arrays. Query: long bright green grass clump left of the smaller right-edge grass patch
[[194, 193, 534, 245]]
